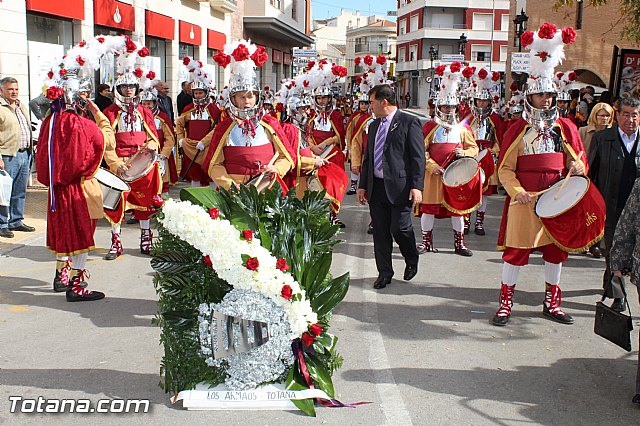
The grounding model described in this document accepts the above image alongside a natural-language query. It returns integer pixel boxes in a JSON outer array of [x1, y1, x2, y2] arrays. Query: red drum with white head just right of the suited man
[[442, 157, 483, 214]]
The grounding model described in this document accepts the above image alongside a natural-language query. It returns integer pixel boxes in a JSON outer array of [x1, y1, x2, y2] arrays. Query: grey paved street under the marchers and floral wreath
[[0, 181, 640, 426]]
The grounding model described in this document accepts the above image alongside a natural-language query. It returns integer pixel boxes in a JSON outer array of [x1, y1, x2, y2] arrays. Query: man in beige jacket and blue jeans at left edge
[[0, 77, 35, 238]]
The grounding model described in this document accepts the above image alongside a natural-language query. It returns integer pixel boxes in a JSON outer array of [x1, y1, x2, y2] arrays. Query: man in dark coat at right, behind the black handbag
[[589, 98, 640, 312]]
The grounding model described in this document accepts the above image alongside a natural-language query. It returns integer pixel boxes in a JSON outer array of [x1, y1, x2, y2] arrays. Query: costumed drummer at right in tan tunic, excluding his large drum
[[493, 23, 587, 326]]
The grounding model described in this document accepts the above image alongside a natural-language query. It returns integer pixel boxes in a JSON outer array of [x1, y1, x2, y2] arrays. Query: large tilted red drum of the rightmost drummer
[[535, 176, 606, 253]]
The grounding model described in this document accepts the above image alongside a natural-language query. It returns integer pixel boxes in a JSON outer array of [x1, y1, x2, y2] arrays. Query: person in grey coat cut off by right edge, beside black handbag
[[610, 179, 640, 404]]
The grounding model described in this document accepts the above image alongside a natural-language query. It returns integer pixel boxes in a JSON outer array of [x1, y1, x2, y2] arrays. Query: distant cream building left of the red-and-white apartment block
[[345, 19, 398, 92]]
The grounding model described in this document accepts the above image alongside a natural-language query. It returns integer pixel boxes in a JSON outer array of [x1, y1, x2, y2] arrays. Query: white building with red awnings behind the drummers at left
[[0, 0, 311, 108]]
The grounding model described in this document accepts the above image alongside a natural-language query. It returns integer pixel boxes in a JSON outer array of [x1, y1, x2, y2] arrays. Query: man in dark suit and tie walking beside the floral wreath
[[357, 84, 425, 289]]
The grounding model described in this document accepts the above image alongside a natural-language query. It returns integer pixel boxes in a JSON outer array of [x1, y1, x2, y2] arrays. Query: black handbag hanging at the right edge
[[593, 277, 633, 352]]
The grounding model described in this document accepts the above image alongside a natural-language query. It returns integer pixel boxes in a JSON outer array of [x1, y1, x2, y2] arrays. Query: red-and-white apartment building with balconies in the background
[[396, 0, 511, 107]]
